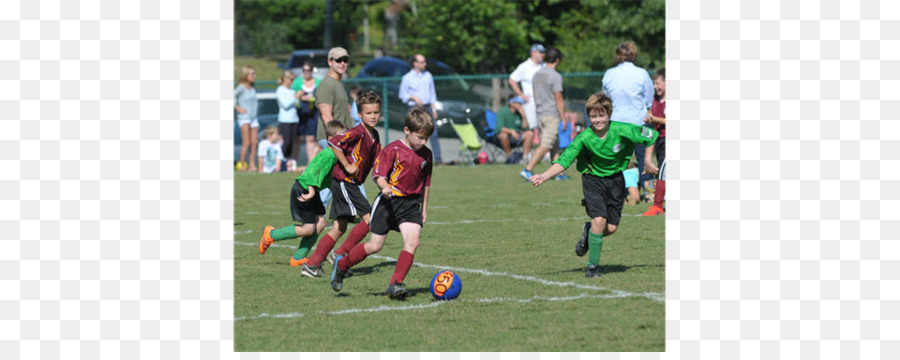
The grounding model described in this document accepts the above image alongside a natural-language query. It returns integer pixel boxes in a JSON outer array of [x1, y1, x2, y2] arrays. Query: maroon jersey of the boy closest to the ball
[[372, 140, 432, 196]]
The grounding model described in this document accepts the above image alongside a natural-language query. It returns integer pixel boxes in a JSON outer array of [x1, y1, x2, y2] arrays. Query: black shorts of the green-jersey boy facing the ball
[[581, 172, 628, 225]]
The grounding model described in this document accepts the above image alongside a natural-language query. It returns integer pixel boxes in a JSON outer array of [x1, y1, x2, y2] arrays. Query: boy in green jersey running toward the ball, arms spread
[[529, 91, 659, 277]]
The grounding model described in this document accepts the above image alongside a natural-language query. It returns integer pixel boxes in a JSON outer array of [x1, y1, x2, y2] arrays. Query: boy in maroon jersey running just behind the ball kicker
[[300, 91, 381, 277]]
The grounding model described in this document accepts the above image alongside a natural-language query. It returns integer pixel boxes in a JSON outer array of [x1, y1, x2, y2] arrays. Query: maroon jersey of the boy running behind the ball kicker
[[328, 124, 381, 185]]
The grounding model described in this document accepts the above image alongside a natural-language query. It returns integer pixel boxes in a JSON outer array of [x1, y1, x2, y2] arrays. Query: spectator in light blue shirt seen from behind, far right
[[602, 41, 653, 186]]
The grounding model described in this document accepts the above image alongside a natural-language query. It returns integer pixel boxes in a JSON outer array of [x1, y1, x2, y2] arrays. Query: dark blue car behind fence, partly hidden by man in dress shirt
[[350, 56, 489, 137]]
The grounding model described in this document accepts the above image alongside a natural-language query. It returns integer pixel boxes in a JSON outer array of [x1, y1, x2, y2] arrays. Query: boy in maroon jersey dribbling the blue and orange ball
[[331, 106, 434, 300]]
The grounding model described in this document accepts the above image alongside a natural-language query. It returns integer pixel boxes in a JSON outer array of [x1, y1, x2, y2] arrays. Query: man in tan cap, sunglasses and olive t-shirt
[[316, 47, 353, 140]]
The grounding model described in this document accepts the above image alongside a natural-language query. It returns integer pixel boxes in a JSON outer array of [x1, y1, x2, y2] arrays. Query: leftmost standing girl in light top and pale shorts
[[234, 65, 259, 172]]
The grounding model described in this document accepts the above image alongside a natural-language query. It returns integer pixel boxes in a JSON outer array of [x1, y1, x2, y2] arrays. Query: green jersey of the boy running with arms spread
[[553, 121, 659, 177]]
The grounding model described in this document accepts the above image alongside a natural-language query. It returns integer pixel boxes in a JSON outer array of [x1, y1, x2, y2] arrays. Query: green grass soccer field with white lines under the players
[[234, 165, 665, 352]]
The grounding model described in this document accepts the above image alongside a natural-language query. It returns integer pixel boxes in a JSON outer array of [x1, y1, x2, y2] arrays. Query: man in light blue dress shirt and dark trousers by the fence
[[399, 54, 442, 164]]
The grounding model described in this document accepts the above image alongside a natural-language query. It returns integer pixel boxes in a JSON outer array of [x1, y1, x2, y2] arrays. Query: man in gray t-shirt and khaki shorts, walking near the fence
[[519, 48, 569, 181]]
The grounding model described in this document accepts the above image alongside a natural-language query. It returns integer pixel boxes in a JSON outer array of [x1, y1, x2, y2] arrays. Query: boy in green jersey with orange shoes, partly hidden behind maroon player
[[259, 120, 347, 266]]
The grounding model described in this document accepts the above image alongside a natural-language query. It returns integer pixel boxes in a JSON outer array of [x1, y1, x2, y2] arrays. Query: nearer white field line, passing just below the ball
[[234, 293, 648, 321]]
